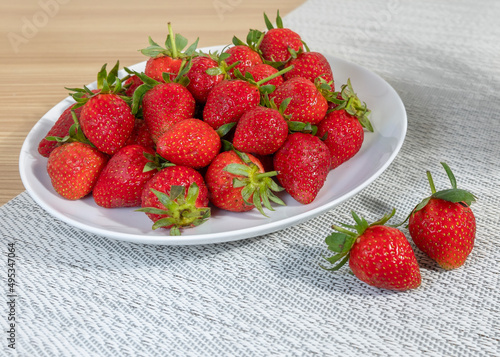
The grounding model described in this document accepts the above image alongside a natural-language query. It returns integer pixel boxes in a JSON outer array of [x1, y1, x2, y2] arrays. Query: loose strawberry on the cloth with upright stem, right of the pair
[[408, 162, 476, 270]]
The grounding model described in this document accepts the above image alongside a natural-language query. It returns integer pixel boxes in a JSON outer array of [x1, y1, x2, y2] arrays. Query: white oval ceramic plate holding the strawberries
[[19, 47, 407, 245]]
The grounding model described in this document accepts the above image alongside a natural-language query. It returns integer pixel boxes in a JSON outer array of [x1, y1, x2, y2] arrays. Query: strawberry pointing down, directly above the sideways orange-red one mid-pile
[[132, 67, 196, 143]]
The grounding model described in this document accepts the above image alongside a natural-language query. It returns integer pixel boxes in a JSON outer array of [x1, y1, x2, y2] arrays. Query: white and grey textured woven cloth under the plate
[[0, 0, 500, 356]]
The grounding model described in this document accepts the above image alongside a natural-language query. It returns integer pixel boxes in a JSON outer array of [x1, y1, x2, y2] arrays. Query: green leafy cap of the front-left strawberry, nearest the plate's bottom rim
[[136, 182, 210, 236]]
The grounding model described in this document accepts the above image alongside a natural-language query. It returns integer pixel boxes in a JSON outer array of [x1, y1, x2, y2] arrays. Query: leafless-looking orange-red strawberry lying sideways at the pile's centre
[[156, 118, 221, 169]]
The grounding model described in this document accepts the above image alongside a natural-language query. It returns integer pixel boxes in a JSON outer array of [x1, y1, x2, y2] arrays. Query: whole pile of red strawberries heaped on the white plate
[[39, 12, 373, 235]]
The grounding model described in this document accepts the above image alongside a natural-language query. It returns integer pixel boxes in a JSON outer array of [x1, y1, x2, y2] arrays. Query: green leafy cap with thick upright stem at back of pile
[[139, 22, 199, 58]]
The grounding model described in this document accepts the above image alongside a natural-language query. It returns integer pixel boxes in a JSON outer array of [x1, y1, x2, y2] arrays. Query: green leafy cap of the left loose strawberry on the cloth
[[320, 209, 396, 271]]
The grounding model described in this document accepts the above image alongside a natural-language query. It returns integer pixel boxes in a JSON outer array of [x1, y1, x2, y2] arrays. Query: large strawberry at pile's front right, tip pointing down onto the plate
[[274, 133, 331, 204]]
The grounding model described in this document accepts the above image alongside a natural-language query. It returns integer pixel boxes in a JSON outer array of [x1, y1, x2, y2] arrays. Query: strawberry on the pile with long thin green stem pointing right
[[203, 68, 291, 130]]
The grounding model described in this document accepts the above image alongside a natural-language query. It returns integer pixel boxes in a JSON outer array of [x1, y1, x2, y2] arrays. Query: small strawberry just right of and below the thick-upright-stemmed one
[[186, 56, 224, 104]]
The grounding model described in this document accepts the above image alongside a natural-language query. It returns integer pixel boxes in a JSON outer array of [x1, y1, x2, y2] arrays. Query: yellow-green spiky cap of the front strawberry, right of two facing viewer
[[223, 143, 285, 217]]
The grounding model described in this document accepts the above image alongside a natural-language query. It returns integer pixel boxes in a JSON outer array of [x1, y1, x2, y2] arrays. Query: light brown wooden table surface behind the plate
[[0, 0, 304, 205]]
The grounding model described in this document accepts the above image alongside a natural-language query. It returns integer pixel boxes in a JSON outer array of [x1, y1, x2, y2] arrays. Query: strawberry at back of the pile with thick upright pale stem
[[141, 22, 198, 82]]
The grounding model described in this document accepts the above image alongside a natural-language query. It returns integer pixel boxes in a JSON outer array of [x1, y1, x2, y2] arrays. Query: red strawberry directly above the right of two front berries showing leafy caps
[[233, 106, 288, 155]]
